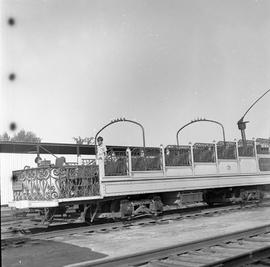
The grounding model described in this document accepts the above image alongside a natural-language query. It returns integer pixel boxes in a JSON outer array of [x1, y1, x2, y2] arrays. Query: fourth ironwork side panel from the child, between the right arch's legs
[[193, 143, 216, 162]]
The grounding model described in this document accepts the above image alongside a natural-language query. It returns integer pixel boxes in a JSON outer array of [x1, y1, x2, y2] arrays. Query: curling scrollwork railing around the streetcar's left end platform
[[13, 165, 100, 201]]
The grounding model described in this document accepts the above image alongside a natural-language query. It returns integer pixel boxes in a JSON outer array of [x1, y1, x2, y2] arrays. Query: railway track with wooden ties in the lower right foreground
[[66, 224, 270, 267]]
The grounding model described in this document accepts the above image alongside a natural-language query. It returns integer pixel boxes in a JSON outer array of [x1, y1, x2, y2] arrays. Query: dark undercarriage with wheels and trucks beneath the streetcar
[[29, 186, 269, 224]]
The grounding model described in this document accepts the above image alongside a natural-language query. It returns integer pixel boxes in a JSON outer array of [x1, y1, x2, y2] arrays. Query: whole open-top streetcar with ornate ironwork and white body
[[7, 120, 270, 222]]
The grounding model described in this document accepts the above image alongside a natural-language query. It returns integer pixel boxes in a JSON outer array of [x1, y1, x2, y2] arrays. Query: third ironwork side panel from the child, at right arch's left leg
[[165, 146, 191, 166]]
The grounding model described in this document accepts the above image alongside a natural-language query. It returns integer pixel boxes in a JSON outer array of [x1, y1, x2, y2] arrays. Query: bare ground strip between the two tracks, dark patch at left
[[2, 207, 270, 267]]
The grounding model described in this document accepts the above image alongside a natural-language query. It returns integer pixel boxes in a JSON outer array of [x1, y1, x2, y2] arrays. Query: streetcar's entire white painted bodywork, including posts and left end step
[[7, 140, 270, 208]]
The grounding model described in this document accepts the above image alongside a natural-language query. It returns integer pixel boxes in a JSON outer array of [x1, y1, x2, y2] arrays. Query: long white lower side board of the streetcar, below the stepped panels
[[102, 173, 270, 197]]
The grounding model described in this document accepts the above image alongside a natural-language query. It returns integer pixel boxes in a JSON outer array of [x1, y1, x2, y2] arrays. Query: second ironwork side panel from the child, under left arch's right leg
[[131, 147, 162, 171]]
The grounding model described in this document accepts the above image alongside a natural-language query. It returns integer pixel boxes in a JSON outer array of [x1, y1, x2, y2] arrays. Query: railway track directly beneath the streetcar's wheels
[[1, 198, 270, 239]]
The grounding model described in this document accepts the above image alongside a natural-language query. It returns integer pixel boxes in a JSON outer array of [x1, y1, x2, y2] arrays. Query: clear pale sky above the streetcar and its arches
[[0, 0, 270, 146]]
